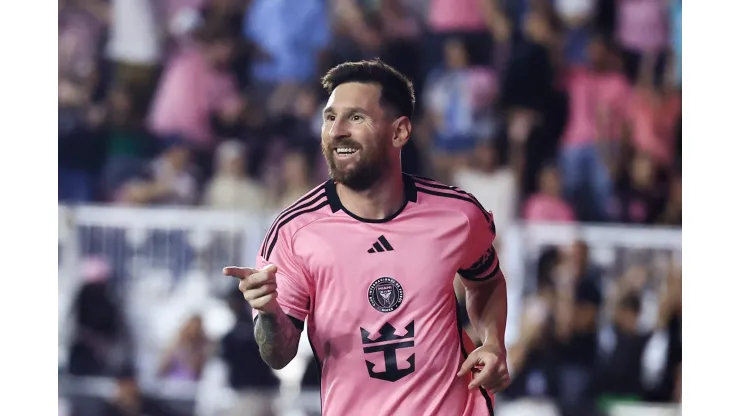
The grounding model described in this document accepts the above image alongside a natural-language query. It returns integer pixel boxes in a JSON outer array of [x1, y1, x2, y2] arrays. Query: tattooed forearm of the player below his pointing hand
[[254, 311, 301, 370]]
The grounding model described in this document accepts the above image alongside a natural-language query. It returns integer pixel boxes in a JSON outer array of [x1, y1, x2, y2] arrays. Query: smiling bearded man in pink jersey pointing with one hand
[[224, 60, 509, 416]]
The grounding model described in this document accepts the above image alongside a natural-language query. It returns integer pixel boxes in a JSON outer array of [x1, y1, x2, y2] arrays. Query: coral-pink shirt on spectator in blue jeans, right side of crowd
[[562, 68, 630, 150]]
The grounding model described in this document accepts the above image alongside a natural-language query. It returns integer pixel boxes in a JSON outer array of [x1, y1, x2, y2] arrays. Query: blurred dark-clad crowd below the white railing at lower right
[[504, 241, 682, 416]]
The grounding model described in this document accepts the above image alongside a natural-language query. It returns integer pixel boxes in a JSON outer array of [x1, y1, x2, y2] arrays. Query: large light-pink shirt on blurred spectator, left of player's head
[[149, 48, 239, 147]]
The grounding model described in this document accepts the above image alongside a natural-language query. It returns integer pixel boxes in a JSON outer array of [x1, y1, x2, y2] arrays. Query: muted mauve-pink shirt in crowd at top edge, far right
[[617, 0, 668, 53]]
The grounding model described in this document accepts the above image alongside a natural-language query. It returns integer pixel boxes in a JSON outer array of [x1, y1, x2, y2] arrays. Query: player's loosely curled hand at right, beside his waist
[[457, 344, 511, 394]]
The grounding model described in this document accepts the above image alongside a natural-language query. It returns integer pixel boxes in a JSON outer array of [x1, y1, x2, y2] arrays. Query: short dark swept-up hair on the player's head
[[321, 58, 416, 118]]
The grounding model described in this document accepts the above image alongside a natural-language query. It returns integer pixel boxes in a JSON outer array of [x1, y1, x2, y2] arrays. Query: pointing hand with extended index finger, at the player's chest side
[[224, 264, 280, 314]]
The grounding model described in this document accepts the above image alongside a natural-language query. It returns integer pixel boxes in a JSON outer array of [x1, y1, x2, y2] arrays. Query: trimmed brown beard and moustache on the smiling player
[[321, 142, 389, 191]]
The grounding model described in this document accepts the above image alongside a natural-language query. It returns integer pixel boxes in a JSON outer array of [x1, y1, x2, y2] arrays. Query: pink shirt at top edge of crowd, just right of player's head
[[427, 0, 487, 32]]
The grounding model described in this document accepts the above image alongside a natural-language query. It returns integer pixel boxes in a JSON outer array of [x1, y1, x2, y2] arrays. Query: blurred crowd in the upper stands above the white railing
[[59, 0, 681, 227]]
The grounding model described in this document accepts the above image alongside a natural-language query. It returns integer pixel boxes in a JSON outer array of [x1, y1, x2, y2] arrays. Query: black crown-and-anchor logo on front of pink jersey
[[360, 321, 416, 382]]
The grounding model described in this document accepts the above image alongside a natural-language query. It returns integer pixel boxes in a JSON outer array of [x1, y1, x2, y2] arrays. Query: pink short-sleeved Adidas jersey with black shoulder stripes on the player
[[255, 175, 502, 416]]
